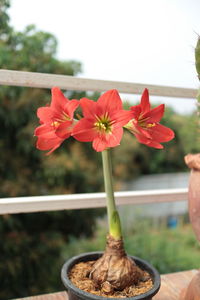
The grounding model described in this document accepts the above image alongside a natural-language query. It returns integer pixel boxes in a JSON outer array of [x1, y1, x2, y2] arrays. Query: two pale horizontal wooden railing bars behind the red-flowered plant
[[0, 70, 197, 214]]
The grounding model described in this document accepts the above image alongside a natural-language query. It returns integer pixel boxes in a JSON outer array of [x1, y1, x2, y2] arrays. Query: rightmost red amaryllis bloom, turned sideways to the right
[[124, 89, 174, 149]]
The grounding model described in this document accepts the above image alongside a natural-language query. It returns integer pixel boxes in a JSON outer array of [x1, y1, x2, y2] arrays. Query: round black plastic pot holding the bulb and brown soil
[[61, 252, 160, 300]]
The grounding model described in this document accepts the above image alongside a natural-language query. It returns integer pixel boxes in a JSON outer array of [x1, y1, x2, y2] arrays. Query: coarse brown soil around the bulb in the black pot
[[69, 261, 153, 298]]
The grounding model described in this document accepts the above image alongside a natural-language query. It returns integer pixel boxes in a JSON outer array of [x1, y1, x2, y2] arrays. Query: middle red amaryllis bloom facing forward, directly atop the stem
[[72, 90, 131, 152]]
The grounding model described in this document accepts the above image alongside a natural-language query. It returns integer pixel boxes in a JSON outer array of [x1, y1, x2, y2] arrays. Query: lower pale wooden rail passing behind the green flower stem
[[0, 189, 188, 214]]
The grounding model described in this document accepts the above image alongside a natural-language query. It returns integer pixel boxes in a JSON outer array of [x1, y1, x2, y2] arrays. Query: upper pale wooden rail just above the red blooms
[[0, 70, 197, 99]]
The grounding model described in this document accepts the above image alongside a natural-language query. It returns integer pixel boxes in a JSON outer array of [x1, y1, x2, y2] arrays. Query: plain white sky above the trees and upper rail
[[10, 0, 200, 112]]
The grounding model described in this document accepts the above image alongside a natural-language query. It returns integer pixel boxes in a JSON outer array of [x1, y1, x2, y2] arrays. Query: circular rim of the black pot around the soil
[[61, 251, 160, 300]]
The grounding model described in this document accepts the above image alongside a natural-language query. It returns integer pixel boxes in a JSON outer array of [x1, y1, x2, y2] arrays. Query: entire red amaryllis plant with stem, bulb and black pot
[[35, 87, 174, 300]]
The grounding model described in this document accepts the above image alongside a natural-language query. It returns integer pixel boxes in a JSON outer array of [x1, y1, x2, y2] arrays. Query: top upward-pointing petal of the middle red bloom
[[97, 90, 123, 113]]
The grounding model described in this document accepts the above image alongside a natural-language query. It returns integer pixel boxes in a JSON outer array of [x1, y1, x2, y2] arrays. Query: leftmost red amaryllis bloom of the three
[[34, 87, 79, 154]]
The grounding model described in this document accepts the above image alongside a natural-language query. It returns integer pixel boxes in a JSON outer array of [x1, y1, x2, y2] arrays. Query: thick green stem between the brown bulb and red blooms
[[102, 149, 122, 240]]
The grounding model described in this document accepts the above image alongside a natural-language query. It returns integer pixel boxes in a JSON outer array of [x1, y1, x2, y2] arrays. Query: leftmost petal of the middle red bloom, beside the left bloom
[[72, 119, 98, 142]]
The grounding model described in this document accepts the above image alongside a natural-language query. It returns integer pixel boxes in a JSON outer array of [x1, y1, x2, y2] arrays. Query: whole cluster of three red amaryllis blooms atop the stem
[[35, 87, 174, 154]]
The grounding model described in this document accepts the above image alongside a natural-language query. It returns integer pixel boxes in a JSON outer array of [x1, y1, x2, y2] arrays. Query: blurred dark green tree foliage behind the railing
[[0, 0, 199, 299]]
